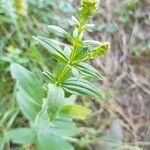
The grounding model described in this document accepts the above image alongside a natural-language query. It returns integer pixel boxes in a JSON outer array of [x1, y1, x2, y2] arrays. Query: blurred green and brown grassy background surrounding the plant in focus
[[0, 0, 150, 150]]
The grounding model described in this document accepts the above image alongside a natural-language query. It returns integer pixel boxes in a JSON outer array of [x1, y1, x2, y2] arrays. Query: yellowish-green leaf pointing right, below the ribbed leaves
[[61, 105, 91, 119]]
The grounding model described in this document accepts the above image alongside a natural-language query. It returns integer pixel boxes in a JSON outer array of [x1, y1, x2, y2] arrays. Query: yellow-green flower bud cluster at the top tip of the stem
[[81, 0, 100, 22]]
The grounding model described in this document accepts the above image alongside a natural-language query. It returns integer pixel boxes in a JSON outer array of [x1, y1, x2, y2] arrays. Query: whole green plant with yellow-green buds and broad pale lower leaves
[[2, 1, 109, 150]]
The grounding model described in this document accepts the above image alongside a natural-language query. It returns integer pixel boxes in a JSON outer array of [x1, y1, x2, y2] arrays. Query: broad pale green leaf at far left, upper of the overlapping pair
[[11, 64, 44, 104]]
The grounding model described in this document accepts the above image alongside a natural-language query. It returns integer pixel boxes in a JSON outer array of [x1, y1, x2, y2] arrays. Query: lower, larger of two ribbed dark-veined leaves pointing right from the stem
[[62, 78, 102, 100]]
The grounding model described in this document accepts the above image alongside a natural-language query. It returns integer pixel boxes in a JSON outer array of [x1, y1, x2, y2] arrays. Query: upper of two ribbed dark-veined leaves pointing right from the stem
[[74, 63, 102, 80]]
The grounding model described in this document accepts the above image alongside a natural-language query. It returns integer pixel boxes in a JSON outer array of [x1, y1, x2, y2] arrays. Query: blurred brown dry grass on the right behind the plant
[[85, 0, 150, 150]]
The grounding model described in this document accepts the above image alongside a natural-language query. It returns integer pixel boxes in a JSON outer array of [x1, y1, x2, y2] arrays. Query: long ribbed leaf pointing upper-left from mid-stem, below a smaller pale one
[[33, 36, 67, 62]]
